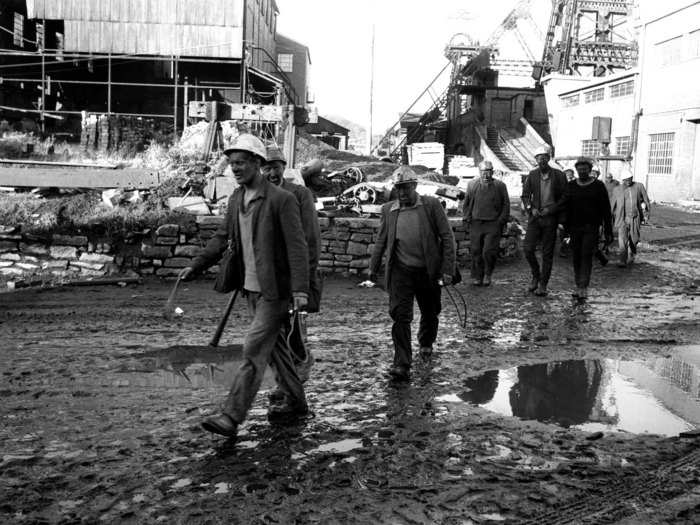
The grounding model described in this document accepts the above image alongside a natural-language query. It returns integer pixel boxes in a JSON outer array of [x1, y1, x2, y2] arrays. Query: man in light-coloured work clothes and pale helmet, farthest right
[[612, 167, 651, 268]]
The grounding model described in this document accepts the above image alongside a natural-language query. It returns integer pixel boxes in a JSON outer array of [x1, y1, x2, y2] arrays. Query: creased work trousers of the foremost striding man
[[223, 292, 306, 423]]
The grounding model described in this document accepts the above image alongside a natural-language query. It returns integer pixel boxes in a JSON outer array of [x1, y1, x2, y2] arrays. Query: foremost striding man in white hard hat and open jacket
[[180, 134, 309, 437]]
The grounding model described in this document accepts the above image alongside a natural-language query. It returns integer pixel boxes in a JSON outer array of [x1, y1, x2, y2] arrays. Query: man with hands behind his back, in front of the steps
[[462, 160, 510, 286]]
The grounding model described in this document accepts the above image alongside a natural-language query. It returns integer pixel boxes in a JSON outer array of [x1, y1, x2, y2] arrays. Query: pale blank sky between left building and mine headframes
[[277, 0, 528, 134]]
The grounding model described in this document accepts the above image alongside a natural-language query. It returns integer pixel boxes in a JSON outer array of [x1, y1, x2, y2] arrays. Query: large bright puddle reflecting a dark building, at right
[[446, 346, 700, 436]]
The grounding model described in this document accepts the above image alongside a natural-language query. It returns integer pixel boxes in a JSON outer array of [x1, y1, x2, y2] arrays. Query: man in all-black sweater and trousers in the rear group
[[565, 157, 612, 300]]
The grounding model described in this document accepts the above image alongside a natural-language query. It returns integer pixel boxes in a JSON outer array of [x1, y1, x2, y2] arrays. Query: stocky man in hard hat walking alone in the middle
[[369, 166, 456, 381]]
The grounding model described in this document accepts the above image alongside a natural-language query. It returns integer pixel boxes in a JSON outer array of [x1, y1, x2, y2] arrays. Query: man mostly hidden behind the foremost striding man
[[263, 147, 321, 386]]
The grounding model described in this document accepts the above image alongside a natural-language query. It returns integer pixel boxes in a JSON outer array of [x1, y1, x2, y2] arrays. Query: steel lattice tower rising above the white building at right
[[541, 0, 638, 76]]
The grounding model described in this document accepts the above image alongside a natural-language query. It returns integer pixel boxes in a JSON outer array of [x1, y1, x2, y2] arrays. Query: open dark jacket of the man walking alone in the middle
[[369, 195, 455, 290]]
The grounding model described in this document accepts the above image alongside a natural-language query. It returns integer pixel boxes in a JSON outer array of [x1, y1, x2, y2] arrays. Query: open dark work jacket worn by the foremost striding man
[[192, 179, 309, 300]]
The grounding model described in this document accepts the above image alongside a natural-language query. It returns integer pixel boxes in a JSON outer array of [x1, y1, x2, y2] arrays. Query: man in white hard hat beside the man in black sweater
[[522, 146, 566, 296]]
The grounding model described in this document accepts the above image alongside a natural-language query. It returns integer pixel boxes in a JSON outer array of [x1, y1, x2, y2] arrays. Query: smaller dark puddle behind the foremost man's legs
[[103, 345, 275, 389]]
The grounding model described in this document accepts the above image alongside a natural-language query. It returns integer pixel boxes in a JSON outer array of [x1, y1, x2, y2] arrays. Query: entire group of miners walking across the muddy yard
[[180, 134, 648, 437]]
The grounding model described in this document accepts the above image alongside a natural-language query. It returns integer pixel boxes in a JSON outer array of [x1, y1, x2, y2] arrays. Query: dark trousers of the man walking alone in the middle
[[389, 262, 441, 367]]
